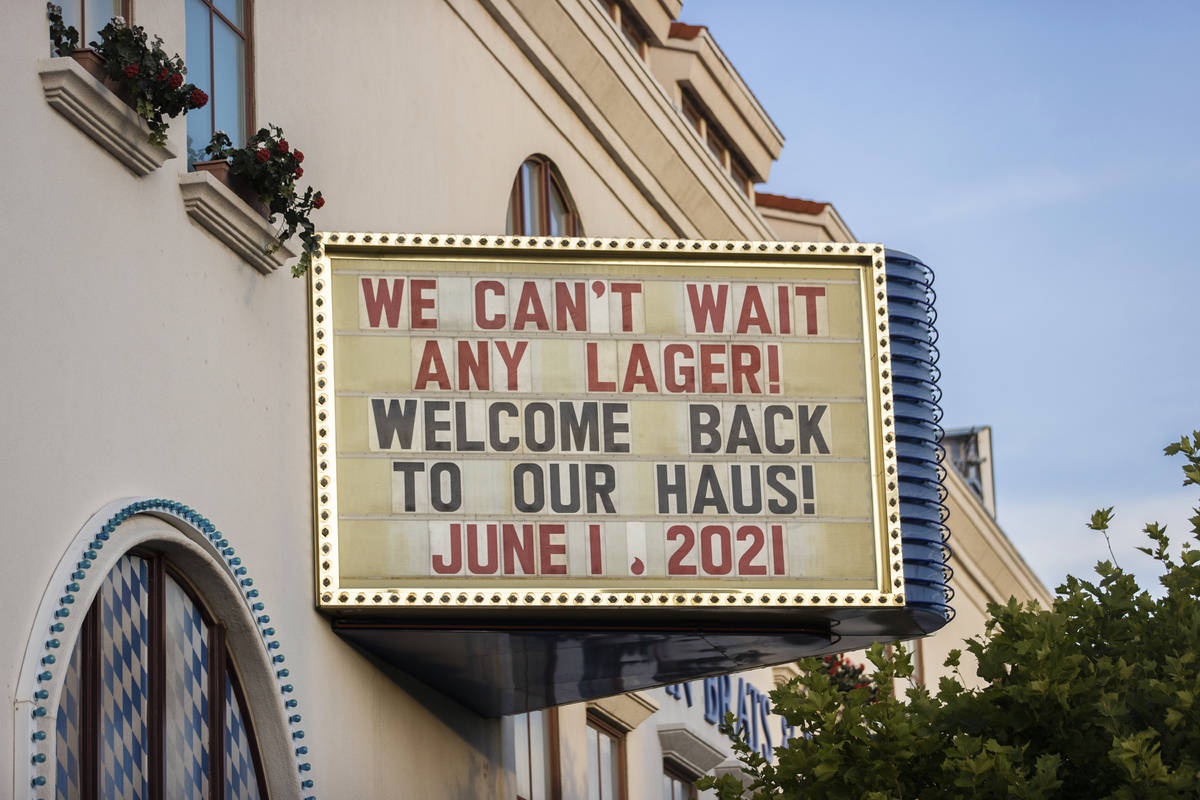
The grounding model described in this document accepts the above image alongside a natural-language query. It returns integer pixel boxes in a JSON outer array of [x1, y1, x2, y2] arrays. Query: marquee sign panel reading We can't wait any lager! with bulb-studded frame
[[311, 234, 904, 618]]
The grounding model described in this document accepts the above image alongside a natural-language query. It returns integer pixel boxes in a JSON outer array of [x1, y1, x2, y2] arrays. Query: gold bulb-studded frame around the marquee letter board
[[308, 231, 904, 616]]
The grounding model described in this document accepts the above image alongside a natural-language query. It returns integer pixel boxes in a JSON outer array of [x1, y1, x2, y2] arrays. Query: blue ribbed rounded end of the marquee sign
[[886, 249, 954, 627]]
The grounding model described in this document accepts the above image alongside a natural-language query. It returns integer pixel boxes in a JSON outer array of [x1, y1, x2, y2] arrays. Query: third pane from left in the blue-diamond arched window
[[163, 578, 209, 800]]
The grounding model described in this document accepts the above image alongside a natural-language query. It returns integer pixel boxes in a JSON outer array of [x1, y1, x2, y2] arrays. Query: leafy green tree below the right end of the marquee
[[698, 431, 1200, 800]]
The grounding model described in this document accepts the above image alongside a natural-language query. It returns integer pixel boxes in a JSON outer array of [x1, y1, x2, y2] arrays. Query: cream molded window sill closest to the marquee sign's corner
[[179, 173, 300, 275]]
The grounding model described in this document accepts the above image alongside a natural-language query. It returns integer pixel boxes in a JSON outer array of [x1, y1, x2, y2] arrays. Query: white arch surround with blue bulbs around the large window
[[21, 498, 316, 800]]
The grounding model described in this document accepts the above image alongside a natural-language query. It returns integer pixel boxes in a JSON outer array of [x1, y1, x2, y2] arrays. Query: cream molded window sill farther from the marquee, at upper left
[[37, 58, 179, 175]]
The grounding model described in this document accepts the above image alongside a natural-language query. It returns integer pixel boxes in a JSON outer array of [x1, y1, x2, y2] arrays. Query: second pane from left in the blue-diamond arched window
[[100, 555, 150, 800]]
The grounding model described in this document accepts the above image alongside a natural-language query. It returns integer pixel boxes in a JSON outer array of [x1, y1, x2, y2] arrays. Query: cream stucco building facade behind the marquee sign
[[0, 0, 1048, 800]]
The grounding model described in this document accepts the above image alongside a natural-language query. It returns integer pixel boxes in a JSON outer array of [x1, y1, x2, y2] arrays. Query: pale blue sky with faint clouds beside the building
[[682, 0, 1200, 589]]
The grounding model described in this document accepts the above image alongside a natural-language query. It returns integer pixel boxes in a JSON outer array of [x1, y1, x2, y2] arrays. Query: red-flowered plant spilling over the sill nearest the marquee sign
[[204, 125, 325, 277]]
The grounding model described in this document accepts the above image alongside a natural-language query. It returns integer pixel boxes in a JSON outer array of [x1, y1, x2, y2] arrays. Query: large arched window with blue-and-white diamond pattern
[[55, 552, 266, 800]]
